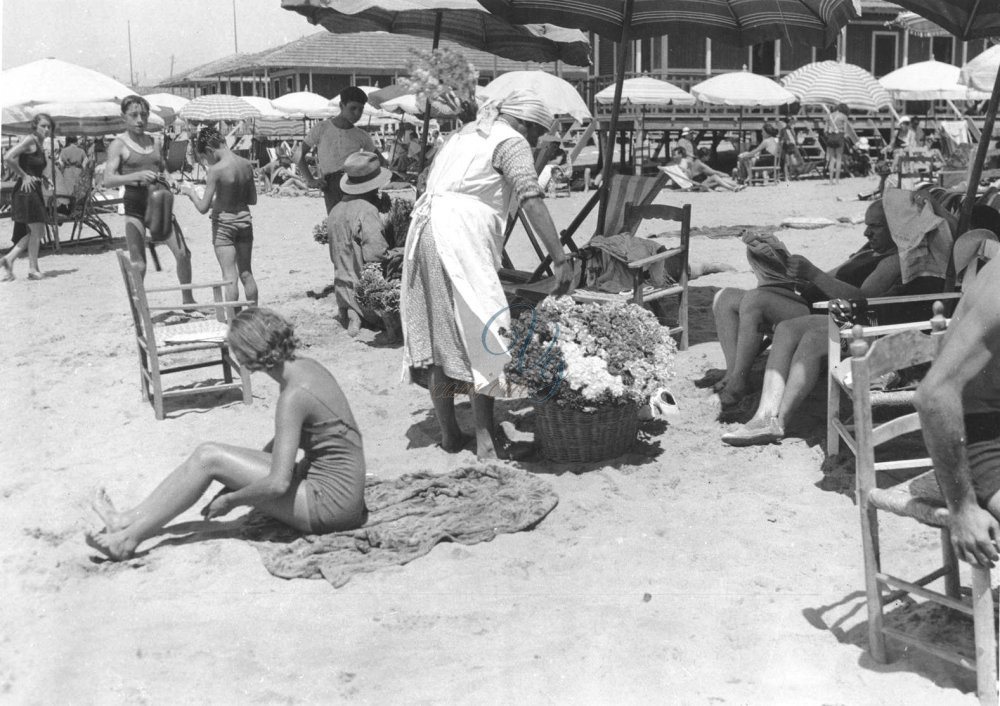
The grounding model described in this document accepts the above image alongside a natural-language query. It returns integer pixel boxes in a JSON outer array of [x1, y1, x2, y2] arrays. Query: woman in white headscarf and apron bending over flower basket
[[401, 91, 573, 459]]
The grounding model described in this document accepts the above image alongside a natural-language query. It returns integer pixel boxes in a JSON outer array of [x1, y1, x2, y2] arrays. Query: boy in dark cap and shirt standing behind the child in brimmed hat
[[295, 86, 384, 215]]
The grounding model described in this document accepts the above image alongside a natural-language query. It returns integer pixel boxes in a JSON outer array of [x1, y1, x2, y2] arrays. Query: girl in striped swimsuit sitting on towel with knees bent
[[86, 308, 367, 561]]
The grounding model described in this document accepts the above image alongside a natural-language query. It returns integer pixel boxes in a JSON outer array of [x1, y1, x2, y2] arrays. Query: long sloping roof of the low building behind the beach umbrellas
[[192, 31, 587, 80]]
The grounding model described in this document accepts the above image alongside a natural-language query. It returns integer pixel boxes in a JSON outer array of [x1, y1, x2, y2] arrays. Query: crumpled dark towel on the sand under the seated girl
[[241, 463, 559, 588]]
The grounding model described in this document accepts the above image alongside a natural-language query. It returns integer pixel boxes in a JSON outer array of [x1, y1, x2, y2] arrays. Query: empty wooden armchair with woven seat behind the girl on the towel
[[118, 250, 253, 419]]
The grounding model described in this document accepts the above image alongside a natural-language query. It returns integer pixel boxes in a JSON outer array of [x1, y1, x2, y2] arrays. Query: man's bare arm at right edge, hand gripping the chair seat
[[914, 260, 1000, 566]]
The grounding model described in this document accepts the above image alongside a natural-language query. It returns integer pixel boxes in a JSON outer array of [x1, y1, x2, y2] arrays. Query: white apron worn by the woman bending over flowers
[[400, 120, 524, 397]]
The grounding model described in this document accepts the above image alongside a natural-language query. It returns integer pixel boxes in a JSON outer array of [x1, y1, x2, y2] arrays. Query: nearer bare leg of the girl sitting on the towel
[[87, 443, 309, 561]]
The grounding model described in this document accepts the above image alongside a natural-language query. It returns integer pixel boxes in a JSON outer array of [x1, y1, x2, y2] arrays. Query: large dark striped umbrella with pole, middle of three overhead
[[479, 0, 859, 228]]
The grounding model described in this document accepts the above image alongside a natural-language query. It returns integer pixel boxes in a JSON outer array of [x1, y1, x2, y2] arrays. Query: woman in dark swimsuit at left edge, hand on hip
[[0, 113, 55, 282]]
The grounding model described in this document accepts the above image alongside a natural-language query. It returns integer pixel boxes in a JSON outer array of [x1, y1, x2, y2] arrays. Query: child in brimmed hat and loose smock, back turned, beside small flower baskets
[[326, 152, 392, 337]]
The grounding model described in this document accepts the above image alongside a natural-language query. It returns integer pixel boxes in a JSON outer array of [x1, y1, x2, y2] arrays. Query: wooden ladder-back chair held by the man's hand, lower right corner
[[850, 314, 997, 706]]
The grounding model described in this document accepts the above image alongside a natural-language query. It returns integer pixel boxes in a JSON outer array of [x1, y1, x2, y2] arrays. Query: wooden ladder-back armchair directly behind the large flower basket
[[572, 204, 691, 351]]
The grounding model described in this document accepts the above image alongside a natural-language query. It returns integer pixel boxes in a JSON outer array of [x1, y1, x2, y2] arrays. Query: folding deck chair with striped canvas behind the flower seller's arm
[[500, 173, 668, 298]]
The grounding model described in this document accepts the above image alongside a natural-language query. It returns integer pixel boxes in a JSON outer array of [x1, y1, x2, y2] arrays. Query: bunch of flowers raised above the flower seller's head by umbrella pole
[[400, 48, 479, 114]]
